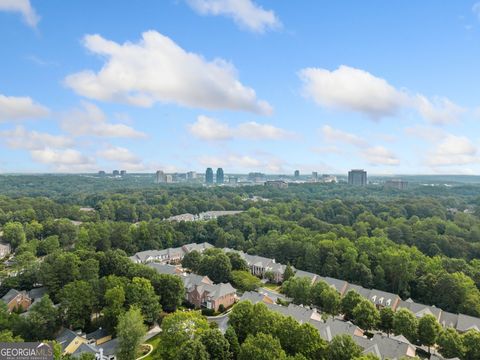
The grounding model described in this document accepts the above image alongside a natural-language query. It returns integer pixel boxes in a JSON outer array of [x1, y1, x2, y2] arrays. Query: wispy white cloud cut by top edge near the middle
[[187, 0, 282, 33]]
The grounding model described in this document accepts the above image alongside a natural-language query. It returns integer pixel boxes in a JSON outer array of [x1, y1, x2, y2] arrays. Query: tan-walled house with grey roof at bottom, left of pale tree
[[55, 328, 118, 360]]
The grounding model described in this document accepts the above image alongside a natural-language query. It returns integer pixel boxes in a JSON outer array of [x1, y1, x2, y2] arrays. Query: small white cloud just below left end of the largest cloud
[[61, 102, 146, 138]]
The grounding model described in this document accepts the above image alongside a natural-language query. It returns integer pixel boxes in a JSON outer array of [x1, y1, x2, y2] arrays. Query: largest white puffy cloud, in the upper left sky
[[65, 31, 272, 114]]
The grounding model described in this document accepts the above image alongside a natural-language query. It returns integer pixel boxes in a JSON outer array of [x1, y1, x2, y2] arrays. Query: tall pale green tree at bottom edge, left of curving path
[[116, 307, 147, 360]]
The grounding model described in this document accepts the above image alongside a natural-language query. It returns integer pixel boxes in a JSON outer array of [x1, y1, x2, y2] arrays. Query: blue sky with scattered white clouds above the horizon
[[0, 0, 480, 174]]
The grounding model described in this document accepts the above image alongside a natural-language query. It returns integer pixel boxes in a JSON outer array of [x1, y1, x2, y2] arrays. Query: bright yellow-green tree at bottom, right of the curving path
[[159, 311, 210, 359]]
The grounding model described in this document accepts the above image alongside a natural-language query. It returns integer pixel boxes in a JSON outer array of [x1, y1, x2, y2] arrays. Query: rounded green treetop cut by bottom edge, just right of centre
[[238, 333, 287, 360]]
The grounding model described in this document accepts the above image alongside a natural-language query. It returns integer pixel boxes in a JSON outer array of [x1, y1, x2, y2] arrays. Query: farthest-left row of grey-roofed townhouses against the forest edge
[[130, 242, 213, 264]]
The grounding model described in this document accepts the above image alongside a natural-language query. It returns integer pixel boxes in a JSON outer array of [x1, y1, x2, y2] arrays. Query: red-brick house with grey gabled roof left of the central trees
[[182, 274, 236, 311]]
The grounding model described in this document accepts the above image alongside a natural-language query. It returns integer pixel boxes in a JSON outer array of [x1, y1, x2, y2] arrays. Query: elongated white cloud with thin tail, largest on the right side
[[299, 65, 465, 125]]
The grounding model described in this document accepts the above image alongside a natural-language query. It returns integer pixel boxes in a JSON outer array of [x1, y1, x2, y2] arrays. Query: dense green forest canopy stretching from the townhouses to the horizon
[[0, 175, 480, 358]]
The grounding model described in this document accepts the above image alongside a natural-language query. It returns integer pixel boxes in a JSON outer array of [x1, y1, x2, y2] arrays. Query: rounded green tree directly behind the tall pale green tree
[[126, 277, 162, 324]]
